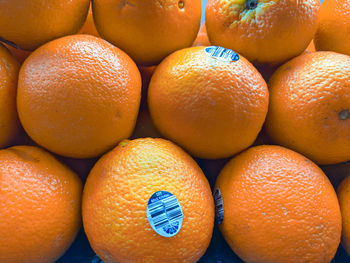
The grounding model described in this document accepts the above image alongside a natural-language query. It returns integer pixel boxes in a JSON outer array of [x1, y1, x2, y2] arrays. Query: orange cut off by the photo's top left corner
[[0, 0, 90, 50]]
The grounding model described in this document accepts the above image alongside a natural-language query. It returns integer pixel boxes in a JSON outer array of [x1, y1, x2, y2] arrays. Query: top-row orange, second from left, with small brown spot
[[92, 0, 201, 65]]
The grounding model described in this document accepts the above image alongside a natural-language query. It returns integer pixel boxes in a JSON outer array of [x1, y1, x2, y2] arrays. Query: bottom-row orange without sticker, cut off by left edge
[[0, 146, 82, 263]]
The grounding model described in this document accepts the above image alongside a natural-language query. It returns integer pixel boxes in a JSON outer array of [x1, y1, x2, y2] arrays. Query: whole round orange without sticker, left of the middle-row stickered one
[[17, 35, 141, 158]]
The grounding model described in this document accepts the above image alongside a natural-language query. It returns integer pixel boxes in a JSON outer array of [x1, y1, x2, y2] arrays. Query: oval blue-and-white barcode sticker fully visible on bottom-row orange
[[147, 191, 183, 237]]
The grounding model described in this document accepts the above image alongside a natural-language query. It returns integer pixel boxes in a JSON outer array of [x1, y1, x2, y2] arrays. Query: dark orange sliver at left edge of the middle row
[[0, 43, 20, 148]]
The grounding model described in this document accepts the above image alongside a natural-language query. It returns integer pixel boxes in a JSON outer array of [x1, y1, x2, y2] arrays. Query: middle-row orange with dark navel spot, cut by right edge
[[265, 52, 350, 164]]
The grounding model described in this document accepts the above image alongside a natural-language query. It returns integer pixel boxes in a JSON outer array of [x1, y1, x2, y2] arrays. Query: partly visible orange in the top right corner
[[315, 0, 350, 56]]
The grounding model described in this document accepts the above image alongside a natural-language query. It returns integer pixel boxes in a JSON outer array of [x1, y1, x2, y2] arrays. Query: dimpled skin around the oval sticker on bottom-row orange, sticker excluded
[[83, 138, 214, 262]]
